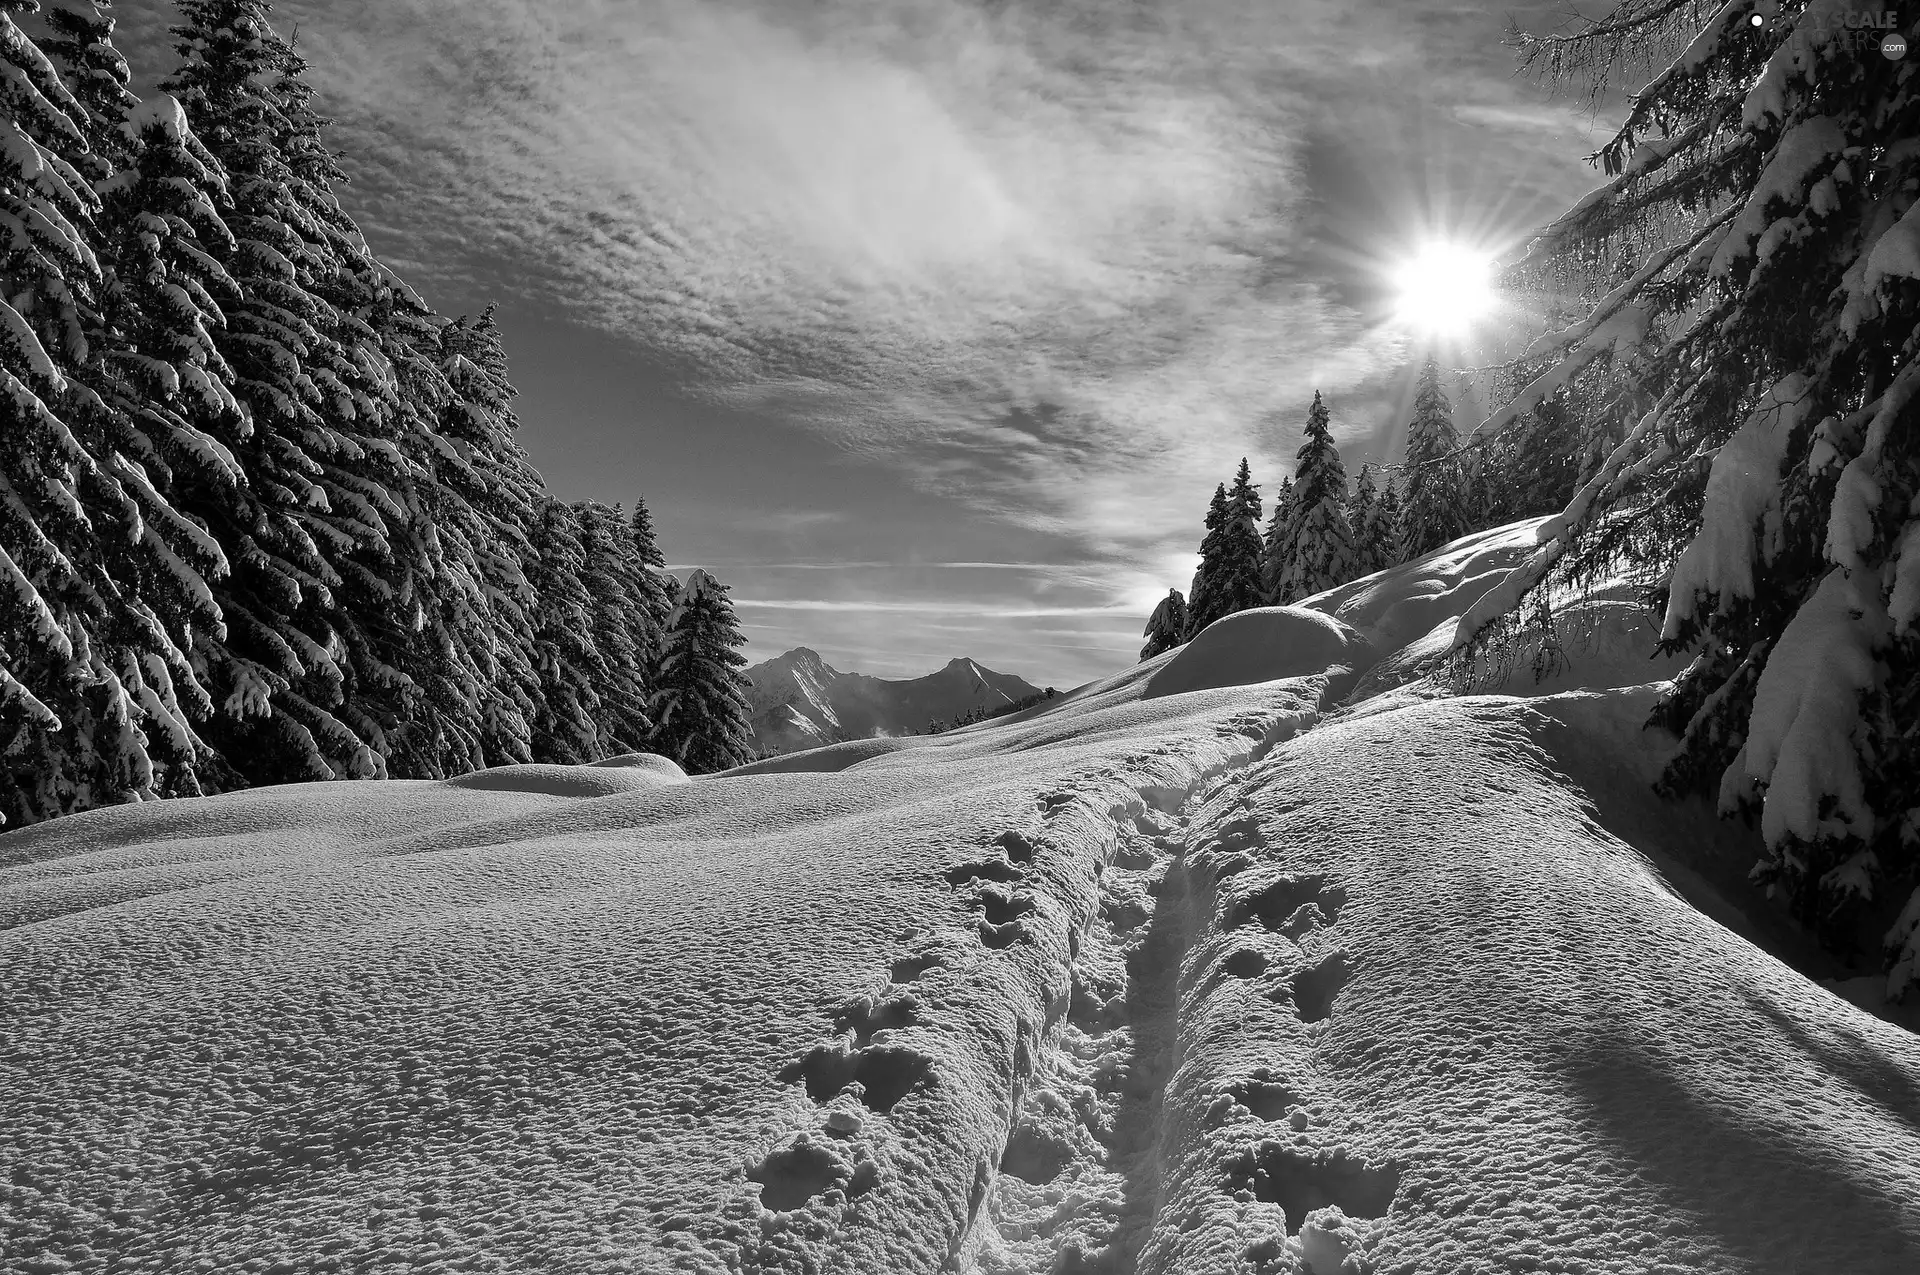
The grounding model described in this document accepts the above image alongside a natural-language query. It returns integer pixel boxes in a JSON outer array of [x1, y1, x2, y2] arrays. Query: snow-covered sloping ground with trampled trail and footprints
[[0, 524, 1920, 1275]]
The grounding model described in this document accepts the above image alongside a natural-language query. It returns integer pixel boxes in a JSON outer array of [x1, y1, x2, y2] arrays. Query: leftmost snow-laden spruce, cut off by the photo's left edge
[[0, 4, 232, 822]]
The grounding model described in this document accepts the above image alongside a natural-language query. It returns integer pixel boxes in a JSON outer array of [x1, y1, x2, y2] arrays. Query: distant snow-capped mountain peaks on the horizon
[[747, 647, 1041, 753]]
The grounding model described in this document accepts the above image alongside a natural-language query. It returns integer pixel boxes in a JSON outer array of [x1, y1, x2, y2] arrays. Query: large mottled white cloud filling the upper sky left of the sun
[[251, 0, 1466, 553]]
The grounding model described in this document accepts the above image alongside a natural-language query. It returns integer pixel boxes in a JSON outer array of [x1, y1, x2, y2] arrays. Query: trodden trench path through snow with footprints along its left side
[[725, 678, 1329, 1273]]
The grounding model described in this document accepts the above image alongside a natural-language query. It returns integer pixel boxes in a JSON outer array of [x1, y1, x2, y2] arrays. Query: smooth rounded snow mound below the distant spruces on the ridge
[[1142, 607, 1373, 699]]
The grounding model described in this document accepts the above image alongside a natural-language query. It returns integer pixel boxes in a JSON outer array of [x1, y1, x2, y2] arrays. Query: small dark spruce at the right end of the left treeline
[[651, 570, 753, 774]]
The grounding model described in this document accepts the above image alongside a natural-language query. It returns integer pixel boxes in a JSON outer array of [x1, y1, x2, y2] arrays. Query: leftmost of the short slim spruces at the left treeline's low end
[[528, 497, 607, 766]]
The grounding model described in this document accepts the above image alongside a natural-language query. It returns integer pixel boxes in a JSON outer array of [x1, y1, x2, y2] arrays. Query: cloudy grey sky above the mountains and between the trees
[[113, 0, 1605, 687]]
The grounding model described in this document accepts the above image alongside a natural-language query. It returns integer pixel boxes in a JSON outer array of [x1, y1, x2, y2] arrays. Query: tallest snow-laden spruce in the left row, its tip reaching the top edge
[[161, 0, 399, 783]]
